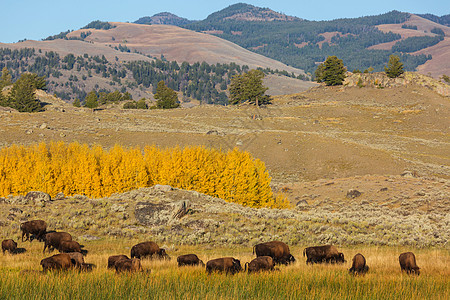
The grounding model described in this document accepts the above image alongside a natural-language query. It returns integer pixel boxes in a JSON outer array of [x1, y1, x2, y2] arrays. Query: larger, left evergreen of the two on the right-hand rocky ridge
[[315, 56, 347, 86]]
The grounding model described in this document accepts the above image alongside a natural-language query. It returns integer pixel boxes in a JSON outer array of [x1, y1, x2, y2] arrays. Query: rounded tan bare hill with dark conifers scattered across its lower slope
[[0, 21, 315, 104]]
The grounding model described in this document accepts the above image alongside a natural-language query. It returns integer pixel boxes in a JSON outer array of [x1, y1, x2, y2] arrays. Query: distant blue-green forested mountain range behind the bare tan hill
[[183, 8, 450, 77]]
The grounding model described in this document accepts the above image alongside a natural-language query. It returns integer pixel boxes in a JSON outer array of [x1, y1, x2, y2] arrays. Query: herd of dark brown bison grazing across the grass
[[2, 220, 420, 275]]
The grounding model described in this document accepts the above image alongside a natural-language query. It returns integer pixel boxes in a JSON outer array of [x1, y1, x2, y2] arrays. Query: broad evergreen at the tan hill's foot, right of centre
[[229, 70, 270, 105]]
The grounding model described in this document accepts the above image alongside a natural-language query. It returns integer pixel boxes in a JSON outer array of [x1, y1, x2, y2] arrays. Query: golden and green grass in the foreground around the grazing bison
[[0, 240, 450, 299]]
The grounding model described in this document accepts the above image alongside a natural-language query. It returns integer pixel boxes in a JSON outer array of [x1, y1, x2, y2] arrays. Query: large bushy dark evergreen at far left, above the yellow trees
[[9, 73, 42, 112]]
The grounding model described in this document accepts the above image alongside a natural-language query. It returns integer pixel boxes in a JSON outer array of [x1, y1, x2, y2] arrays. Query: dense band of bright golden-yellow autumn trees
[[0, 142, 289, 208]]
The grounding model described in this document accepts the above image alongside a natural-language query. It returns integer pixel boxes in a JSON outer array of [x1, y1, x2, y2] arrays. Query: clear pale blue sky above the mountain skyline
[[0, 0, 450, 43]]
